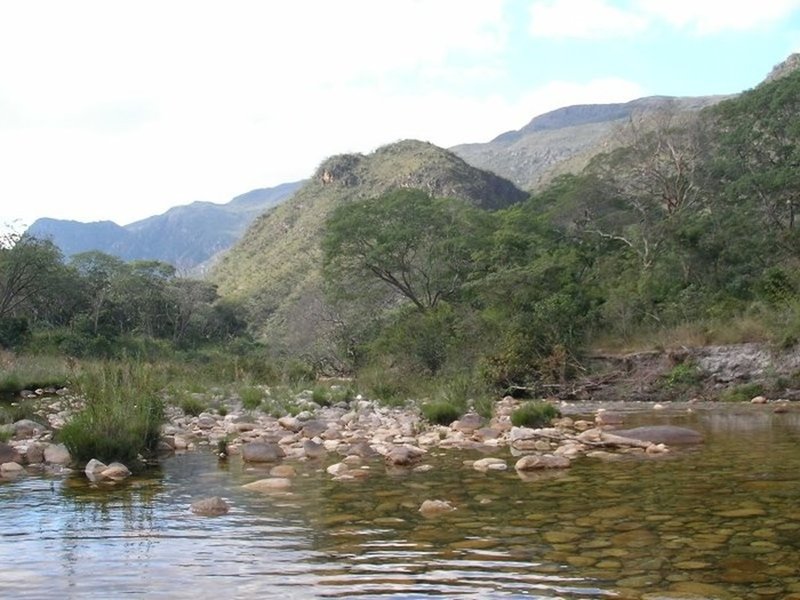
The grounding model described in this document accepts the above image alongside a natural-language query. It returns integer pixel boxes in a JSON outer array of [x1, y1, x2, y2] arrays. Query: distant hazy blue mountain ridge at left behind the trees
[[27, 181, 302, 272]]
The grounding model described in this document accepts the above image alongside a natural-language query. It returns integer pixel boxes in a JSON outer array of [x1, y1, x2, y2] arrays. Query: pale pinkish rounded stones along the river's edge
[[0, 394, 792, 515]]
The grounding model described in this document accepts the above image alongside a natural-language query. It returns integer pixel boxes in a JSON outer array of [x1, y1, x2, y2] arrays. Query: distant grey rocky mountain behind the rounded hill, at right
[[450, 96, 726, 190]]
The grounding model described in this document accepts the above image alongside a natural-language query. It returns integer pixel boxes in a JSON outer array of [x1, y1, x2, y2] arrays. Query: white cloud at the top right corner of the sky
[[638, 0, 800, 35]]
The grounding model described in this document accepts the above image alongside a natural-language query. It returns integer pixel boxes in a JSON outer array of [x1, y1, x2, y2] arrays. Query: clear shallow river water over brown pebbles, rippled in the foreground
[[0, 405, 800, 600]]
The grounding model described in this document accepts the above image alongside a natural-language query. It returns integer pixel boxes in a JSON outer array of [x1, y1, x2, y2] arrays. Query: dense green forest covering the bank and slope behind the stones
[[0, 72, 800, 396]]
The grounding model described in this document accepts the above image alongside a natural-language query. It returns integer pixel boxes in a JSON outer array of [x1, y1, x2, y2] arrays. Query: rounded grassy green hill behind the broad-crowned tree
[[210, 140, 527, 351]]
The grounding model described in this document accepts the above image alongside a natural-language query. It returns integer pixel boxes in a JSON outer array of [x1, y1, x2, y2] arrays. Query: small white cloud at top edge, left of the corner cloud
[[530, 0, 647, 39]]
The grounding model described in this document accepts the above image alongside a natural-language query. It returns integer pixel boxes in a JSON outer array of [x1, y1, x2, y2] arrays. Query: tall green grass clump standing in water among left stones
[[60, 362, 164, 463]]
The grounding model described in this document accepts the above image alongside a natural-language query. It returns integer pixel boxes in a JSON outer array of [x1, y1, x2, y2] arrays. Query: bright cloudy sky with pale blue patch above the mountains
[[0, 0, 800, 230]]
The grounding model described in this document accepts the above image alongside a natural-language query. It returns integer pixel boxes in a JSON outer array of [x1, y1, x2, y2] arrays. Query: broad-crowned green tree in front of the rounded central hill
[[322, 189, 481, 312]]
